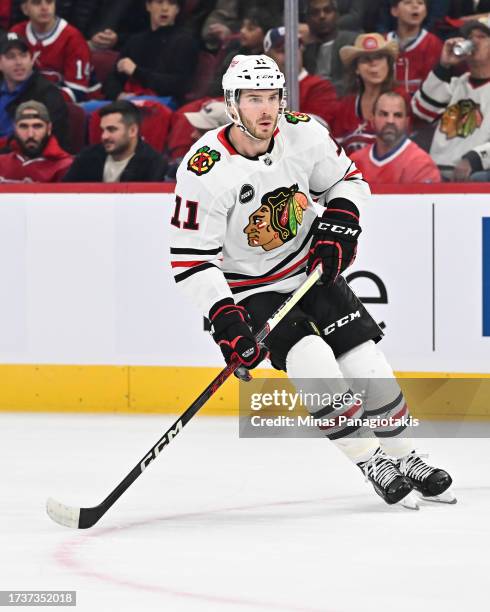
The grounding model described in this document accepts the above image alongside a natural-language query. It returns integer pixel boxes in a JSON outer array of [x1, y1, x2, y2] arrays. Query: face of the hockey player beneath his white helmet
[[238, 89, 280, 140]]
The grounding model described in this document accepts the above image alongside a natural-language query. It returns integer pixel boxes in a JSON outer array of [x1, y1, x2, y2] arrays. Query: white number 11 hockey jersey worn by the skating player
[[170, 111, 370, 315]]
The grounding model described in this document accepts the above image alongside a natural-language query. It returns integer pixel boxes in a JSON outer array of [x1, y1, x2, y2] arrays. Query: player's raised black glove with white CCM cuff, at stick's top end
[[306, 200, 362, 284]]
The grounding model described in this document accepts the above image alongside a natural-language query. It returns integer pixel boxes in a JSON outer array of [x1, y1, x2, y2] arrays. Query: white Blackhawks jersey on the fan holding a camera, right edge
[[412, 66, 490, 166]]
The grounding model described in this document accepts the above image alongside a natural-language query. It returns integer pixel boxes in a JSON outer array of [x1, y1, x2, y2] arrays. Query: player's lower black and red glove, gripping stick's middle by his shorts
[[209, 298, 267, 370]]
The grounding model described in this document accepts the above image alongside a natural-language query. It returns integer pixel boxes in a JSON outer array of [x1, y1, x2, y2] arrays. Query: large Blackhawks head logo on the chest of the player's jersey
[[243, 184, 308, 251]]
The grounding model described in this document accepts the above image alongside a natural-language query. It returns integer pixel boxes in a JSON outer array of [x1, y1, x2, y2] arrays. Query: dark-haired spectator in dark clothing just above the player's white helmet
[[207, 8, 276, 98]]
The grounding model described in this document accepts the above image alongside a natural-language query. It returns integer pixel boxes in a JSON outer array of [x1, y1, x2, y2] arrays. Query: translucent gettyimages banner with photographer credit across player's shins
[[240, 378, 490, 438]]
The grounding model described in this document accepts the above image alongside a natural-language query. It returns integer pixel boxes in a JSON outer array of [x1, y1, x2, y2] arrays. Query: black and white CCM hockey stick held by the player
[[46, 266, 321, 529]]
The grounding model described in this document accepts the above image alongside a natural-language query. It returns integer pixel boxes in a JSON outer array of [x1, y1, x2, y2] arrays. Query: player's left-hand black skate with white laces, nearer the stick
[[357, 448, 418, 510]]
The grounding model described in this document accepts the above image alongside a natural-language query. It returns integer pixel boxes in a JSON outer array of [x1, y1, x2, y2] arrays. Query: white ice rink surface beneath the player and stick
[[0, 414, 490, 612]]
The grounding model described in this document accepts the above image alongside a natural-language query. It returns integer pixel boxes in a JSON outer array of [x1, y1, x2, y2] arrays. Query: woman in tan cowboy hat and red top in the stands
[[332, 33, 398, 155]]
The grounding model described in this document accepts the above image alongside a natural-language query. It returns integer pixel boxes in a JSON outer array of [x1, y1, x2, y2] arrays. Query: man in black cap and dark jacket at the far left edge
[[0, 33, 69, 150]]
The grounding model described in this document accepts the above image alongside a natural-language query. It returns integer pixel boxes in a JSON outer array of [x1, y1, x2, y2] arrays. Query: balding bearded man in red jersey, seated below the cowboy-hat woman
[[351, 91, 441, 183]]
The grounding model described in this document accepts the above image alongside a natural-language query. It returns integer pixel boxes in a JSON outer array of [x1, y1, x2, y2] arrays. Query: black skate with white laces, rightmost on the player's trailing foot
[[396, 451, 457, 504]]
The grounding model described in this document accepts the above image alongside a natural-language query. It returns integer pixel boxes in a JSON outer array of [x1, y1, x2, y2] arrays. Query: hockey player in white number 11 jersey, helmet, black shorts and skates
[[171, 55, 455, 508]]
